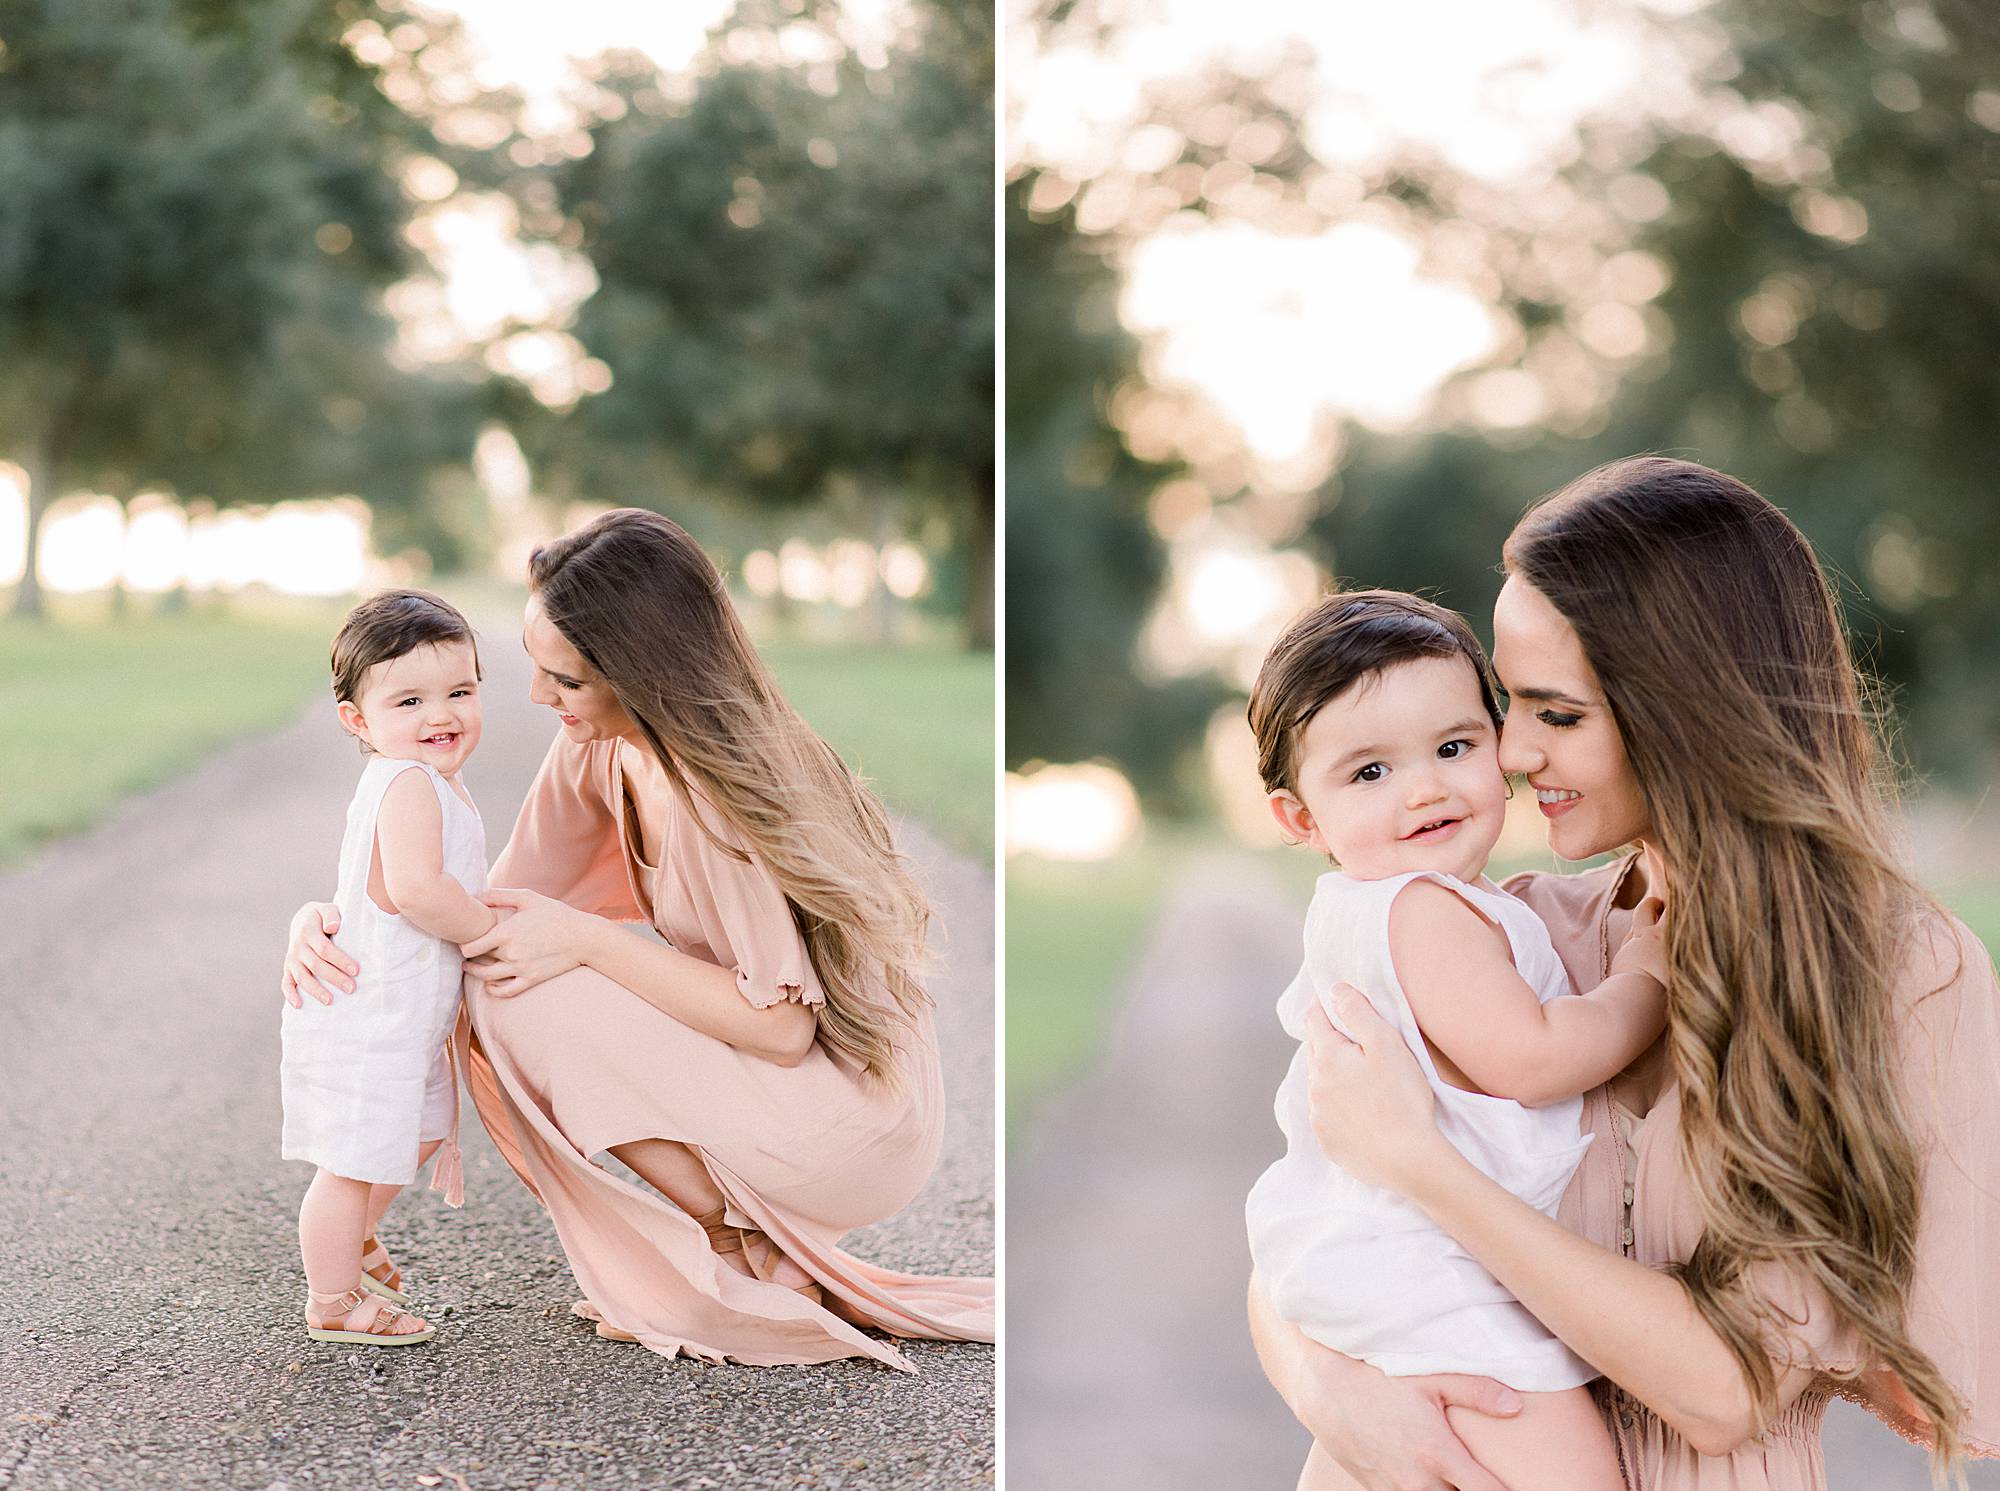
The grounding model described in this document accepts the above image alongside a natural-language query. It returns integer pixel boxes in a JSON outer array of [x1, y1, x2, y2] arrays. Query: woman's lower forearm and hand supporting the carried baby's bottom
[[1250, 1273, 1520, 1491]]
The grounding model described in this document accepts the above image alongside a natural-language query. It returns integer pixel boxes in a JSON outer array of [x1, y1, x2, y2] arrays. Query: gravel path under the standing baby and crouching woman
[[0, 624, 994, 1491]]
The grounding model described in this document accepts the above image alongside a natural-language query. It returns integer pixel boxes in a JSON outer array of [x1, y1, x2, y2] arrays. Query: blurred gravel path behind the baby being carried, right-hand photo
[[1006, 855, 2000, 1491]]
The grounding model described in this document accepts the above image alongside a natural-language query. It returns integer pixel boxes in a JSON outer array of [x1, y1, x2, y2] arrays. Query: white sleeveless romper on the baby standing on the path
[[282, 755, 486, 1183]]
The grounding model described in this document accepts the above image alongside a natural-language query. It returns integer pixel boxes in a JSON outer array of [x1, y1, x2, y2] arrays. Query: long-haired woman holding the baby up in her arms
[[1250, 458, 2000, 1491]]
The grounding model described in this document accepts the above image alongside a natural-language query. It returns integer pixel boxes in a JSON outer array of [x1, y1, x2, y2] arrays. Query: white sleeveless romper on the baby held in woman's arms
[[1246, 871, 1598, 1393]]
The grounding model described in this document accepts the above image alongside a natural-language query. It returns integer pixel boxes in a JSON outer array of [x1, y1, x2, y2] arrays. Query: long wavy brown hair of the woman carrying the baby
[[1506, 456, 1964, 1467]]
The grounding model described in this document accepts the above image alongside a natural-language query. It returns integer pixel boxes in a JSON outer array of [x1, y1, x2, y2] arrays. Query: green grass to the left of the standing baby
[[0, 606, 340, 865]]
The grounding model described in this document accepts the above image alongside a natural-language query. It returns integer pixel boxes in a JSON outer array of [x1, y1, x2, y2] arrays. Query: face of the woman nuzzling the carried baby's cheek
[[1492, 576, 1652, 859]]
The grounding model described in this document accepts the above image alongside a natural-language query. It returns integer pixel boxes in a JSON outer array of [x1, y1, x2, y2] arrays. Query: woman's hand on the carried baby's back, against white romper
[[1306, 983, 1456, 1195]]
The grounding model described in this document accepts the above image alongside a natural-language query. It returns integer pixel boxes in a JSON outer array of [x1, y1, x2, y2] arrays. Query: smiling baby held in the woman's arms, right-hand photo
[[1248, 590, 1666, 1491]]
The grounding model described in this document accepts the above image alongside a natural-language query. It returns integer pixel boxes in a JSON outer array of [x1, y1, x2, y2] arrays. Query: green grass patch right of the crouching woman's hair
[[762, 642, 994, 865]]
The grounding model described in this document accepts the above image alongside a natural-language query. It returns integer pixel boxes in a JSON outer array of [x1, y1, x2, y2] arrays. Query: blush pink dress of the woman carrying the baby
[[1506, 859, 2000, 1491]]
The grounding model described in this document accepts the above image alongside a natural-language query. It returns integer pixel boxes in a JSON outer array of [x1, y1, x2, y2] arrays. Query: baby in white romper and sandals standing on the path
[[282, 590, 496, 1345]]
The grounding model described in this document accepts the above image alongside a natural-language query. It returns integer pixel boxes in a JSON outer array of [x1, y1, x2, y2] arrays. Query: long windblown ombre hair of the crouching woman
[[528, 508, 930, 1085]]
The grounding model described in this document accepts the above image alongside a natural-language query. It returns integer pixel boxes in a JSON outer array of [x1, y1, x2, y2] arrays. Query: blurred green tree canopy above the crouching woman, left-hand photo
[[530, 0, 994, 646]]
